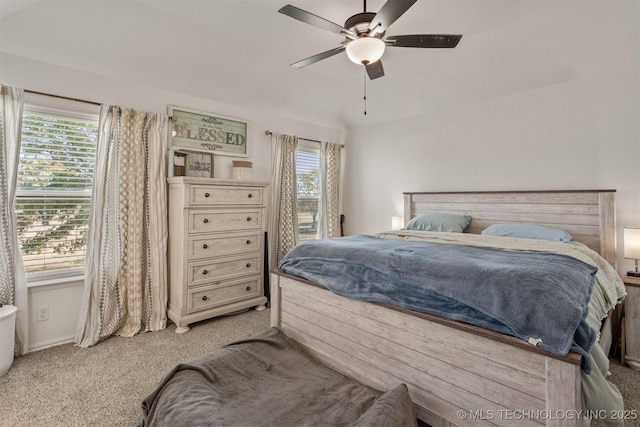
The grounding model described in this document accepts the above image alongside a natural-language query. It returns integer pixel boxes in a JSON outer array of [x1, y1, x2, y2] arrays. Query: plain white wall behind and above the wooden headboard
[[344, 2, 640, 272]]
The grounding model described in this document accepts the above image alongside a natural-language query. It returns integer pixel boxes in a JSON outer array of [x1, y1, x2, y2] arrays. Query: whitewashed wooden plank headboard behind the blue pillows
[[404, 190, 616, 268]]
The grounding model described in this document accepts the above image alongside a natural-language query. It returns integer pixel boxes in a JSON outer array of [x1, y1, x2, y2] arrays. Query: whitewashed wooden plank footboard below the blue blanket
[[271, 273, 581, 427]]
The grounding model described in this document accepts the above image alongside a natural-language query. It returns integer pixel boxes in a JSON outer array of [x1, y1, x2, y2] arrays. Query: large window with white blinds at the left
[[16, 98, 98, 274]]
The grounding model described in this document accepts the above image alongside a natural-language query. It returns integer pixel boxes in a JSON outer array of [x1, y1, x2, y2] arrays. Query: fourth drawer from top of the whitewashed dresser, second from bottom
[[187, 252, 262, 286]]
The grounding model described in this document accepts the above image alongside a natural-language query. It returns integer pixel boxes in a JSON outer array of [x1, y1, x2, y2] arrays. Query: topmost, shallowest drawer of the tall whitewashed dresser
[[189, 185, 263, 206]]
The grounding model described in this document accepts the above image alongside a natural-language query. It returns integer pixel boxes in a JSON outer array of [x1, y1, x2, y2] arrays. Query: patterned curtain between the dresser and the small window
[[269, 134, 298, 268]]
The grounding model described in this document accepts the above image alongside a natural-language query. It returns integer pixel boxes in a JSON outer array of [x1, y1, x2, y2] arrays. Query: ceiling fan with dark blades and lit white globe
[[278, 0, 462, 79]]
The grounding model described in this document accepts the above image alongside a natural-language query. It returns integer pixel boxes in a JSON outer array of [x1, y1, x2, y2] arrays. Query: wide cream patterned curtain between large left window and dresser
[[75, 106, 168, 347]]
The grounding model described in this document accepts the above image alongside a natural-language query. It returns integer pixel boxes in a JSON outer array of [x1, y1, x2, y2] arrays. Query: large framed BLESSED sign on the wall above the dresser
[[169, 105, 249, 157]]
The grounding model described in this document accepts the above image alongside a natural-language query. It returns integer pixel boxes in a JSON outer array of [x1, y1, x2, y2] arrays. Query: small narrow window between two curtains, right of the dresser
[[296, 140, 320, 242]]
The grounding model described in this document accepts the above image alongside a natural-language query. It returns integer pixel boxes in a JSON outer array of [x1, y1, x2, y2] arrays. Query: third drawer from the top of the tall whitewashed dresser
[[188, 231, 262, 260]]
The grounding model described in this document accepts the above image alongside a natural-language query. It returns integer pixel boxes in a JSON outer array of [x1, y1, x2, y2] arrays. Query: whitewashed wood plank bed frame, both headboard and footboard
[[271, 190, 616, 427]]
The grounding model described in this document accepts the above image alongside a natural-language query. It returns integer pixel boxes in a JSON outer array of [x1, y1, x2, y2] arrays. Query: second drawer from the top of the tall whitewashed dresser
[[189, 208, 262, 233]]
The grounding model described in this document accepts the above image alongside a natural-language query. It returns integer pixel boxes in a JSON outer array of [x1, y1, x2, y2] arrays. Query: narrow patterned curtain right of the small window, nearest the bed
[[319, 142, 341, 239]]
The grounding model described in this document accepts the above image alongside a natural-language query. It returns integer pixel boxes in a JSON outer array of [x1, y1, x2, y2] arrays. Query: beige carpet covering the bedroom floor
[[0, 310, 640, 427]]
